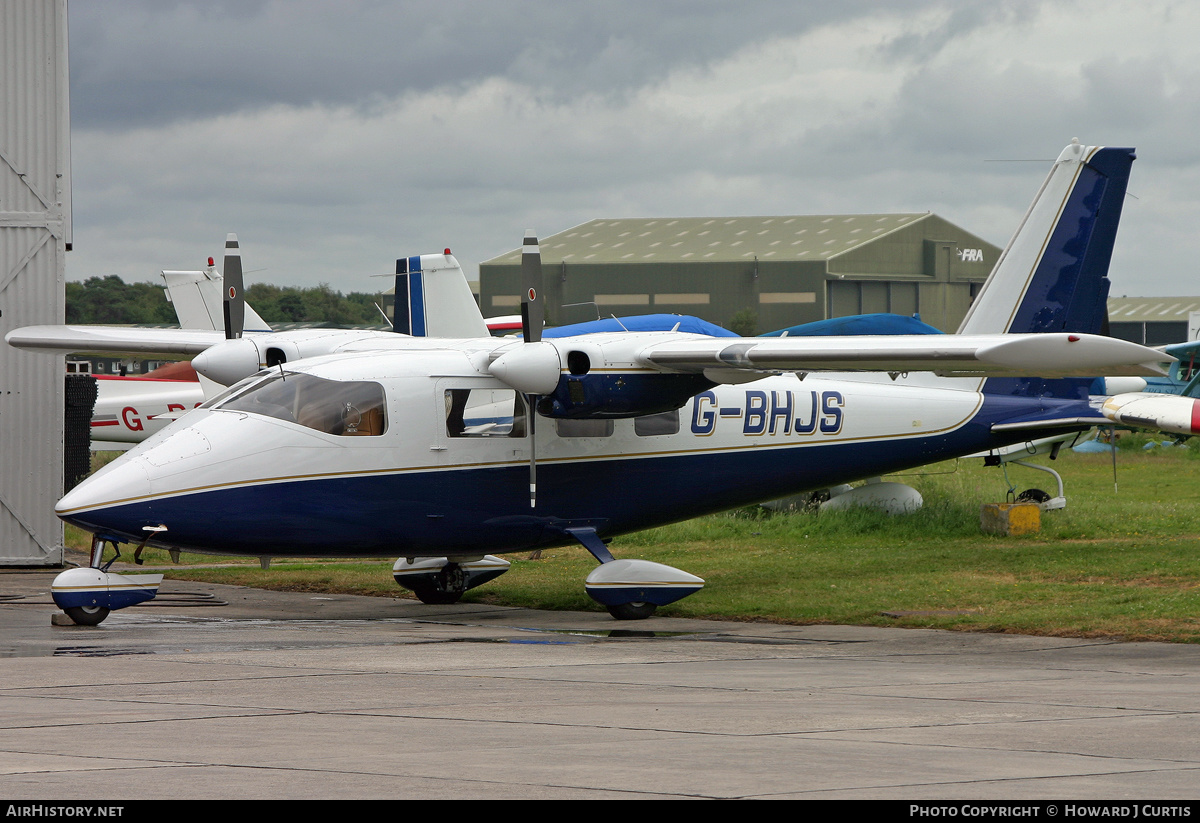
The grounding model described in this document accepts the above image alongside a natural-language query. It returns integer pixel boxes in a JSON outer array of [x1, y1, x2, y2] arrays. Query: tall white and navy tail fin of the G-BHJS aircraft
[[959, 142, 1134, 400]]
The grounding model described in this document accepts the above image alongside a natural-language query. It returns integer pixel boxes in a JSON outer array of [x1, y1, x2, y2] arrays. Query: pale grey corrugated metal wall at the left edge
[[0, 0, 71, 565]]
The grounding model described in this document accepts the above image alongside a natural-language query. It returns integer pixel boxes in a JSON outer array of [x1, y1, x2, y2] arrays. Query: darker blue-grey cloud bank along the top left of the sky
[[70, 0, 902, 130]]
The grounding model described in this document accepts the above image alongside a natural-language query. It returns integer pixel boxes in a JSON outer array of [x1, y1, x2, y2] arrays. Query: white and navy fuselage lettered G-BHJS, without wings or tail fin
[[58, 340, 1079, 557]]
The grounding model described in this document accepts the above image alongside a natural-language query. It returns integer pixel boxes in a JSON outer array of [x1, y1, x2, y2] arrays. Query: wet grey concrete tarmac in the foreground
[[0, 570, 1200, 800]]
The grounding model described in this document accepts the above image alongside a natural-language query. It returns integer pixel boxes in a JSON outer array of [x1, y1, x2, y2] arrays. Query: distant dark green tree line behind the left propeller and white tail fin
[[67, 275, 384, 326]]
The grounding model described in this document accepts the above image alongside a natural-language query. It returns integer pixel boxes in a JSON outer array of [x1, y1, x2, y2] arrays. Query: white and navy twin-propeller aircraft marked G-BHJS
[[10, 142, 1165, 624]]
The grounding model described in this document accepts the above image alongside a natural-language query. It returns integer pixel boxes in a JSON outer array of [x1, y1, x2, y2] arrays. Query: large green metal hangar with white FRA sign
[[479, 214, 1001, 334]]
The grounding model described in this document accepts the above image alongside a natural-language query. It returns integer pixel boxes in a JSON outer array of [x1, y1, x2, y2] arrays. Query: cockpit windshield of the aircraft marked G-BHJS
[[211, 371, 388, 437]]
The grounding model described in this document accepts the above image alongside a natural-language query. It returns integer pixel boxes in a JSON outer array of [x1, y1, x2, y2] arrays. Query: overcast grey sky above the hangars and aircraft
[[67, 0, 1200, 296]]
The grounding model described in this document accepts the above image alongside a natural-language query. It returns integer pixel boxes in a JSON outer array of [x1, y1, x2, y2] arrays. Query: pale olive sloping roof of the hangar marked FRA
[[486, 212, 930, 265]]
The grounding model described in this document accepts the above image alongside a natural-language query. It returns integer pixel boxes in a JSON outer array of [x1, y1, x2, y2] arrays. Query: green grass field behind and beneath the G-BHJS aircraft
[[72, 437, 1200, 642]]
